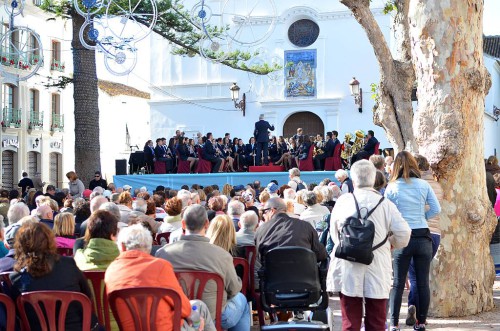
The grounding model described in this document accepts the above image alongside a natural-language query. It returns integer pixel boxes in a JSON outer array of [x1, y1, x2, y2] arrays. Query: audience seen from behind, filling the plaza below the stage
[[0, 156, 498, 331]]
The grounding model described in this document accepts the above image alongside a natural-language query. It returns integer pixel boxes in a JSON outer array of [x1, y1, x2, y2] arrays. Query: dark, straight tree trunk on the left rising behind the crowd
[[71, 12, 101, 185]]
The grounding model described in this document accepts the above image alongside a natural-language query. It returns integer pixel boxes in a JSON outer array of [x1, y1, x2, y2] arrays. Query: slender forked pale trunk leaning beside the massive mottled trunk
[[340, 0, 418, 153]]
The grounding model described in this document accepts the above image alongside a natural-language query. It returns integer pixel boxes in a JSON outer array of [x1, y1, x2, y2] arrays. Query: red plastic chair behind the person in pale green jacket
[[83, 270, 111, 331]]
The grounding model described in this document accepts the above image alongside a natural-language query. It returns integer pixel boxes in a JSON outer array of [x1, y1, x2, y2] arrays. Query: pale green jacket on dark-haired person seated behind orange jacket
[[75, 238, 120, 271]]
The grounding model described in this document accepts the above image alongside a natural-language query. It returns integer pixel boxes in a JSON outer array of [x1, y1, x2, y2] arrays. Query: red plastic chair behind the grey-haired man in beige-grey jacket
[[175, 270, 225, 331]]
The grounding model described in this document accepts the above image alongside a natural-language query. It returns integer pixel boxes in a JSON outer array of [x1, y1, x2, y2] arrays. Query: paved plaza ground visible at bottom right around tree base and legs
[[252, 277, 500, 331]]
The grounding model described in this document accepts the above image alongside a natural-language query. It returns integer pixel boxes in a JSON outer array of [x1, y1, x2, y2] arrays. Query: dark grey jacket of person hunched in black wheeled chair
[[255, 213, 328, 261]]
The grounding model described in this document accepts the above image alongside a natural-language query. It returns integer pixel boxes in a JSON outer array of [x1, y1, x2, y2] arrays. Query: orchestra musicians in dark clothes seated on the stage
[[143, 128, 378, 173]]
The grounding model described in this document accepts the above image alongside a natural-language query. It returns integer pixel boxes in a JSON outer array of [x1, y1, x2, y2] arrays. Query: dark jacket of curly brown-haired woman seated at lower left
[[10, 256, 97, 331]]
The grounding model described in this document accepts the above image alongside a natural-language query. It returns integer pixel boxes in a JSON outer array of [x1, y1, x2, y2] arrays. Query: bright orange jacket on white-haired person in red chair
[[104, 250, 191, 331]]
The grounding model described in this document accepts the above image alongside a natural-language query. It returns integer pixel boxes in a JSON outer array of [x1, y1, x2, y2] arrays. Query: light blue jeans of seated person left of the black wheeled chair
[[222, 293, 250, 331]]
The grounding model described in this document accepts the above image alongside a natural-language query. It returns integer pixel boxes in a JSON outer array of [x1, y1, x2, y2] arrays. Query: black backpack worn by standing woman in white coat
[[335, 194, 389, 265]]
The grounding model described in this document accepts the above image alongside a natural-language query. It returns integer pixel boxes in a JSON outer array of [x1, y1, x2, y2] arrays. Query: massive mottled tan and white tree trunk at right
[[409, 0, 496, 317]]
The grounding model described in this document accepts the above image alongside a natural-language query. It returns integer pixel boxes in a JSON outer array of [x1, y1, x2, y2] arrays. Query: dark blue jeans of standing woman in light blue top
[[390, 233, 432, 325]]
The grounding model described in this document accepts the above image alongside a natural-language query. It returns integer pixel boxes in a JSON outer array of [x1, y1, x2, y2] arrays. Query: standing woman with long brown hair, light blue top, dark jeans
[[385, 151, 441, 331]]
